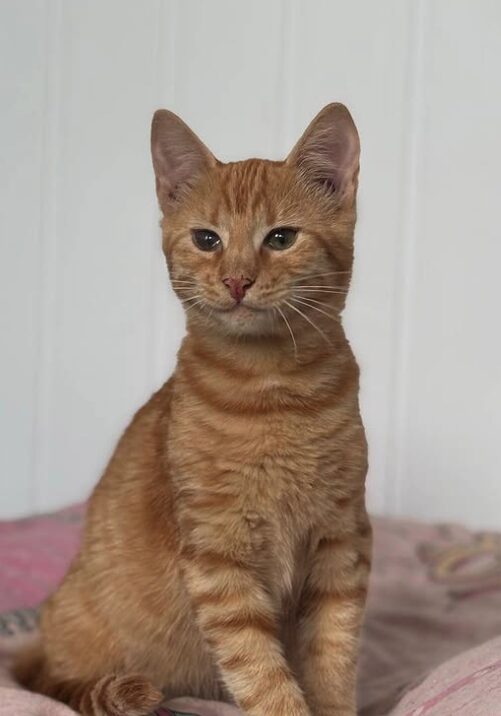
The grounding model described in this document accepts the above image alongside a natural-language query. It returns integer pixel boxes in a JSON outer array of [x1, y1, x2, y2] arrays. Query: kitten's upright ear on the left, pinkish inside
[[151, 109, 216, 214]]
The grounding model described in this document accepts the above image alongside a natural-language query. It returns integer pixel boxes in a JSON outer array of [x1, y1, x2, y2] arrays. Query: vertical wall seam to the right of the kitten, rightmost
[[384, 0, 428, 513]]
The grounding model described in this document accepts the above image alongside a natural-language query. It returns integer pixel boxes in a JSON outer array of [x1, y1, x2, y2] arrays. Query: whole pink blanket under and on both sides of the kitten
[[0, 506, 501, 716]]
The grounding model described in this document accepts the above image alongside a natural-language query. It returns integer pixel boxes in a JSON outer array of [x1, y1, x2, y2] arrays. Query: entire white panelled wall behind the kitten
[[0, 0, 501, 528]]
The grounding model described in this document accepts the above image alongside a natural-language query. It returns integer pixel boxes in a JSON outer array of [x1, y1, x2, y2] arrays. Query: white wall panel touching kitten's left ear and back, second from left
[[37, 0, 162, 509]]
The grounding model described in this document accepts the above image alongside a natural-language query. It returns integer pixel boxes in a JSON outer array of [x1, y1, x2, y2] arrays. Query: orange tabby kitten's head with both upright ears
[[152, 104, 359, 344]]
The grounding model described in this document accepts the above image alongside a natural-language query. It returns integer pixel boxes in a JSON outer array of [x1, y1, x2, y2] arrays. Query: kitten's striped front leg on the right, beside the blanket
[[299, 511, 371, 716]]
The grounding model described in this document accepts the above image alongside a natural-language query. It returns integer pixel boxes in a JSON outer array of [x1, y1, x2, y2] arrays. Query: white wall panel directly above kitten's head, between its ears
[[153, 0, 287, 382]]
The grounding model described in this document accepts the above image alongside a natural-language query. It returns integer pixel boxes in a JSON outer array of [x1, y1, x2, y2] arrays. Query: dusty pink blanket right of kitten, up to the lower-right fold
[[359, 519, 501, 716]]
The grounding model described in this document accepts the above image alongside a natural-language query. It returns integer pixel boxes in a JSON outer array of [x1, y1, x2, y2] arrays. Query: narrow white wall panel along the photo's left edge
[[0, 0, 47, 514]]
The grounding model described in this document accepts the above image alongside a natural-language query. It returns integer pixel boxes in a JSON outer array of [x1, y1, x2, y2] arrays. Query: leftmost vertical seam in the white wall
[[30, 0, 63, 512]]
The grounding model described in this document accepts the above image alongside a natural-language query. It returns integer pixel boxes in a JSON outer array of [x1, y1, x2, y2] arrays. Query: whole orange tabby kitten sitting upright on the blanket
[[17, 104, 371, 716]]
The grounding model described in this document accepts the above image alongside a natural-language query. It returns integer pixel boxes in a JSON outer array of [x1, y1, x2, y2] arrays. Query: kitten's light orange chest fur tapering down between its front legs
[[169, 388, 344, 605]]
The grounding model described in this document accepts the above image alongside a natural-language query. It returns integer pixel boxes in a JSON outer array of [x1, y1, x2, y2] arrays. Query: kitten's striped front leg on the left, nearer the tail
[[176, 515, 310, 716]]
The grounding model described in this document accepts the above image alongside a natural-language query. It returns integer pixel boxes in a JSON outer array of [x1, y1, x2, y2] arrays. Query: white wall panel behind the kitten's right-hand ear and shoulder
[[285, 0, 410, 511]]
